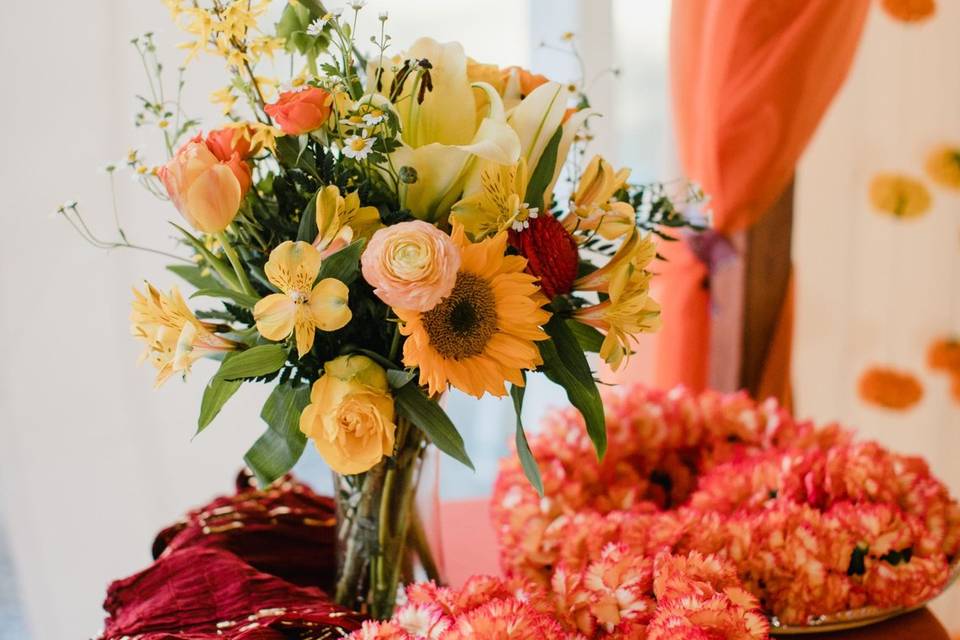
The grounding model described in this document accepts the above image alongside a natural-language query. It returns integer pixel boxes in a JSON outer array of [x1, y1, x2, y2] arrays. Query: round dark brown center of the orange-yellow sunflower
[[421, 271, 497, 360]]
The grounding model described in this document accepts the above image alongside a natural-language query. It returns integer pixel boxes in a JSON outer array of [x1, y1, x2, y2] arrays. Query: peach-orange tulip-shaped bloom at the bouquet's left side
[[159, 135, 251, 233]]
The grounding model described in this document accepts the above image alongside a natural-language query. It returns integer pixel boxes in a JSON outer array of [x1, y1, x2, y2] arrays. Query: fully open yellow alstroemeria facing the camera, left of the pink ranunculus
[[253, 240, 353, 358]]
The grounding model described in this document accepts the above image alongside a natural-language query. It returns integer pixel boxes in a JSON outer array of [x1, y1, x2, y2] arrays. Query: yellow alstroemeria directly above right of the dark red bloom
[[563, 156, 637, 240]]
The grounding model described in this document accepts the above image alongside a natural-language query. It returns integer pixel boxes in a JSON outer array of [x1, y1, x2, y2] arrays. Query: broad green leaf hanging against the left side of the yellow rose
[[243, 382, 310, 487]]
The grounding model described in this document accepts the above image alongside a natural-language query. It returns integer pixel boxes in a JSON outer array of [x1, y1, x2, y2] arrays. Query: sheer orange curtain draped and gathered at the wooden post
[[656, 0, 870, 390]]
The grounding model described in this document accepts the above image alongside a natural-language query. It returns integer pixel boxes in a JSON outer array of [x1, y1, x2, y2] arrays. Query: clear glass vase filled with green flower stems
[[334, 417, 442, 620]]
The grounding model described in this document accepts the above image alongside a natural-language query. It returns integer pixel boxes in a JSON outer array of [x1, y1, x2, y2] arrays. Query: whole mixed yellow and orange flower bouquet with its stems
[[61, 0, 699, 618]]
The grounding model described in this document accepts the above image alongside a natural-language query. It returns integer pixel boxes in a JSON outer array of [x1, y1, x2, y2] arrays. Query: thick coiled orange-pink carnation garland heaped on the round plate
[[491, 386, 960, 637]]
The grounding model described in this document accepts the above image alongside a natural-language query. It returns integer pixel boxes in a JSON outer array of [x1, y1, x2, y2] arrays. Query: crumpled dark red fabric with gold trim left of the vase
[[102, 477, 360, 640]]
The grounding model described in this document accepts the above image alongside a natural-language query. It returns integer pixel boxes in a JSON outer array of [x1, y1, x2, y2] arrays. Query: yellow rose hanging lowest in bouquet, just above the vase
[[300, 355, 396, 475]]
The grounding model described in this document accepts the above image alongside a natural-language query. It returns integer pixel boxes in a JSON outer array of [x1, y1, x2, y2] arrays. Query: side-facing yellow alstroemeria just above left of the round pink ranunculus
[[313, 185, 383, 256]]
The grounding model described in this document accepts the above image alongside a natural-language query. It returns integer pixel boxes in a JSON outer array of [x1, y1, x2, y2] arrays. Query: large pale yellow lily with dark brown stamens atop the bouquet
[[369, 38, 520, 222]]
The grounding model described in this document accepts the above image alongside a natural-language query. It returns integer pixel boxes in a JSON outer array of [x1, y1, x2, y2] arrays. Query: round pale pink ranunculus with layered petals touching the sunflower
[[360, 220, 460, 311]]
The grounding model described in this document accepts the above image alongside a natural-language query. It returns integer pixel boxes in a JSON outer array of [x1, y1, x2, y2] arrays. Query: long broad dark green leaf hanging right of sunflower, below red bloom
[[537, 315, 607, 459]]
